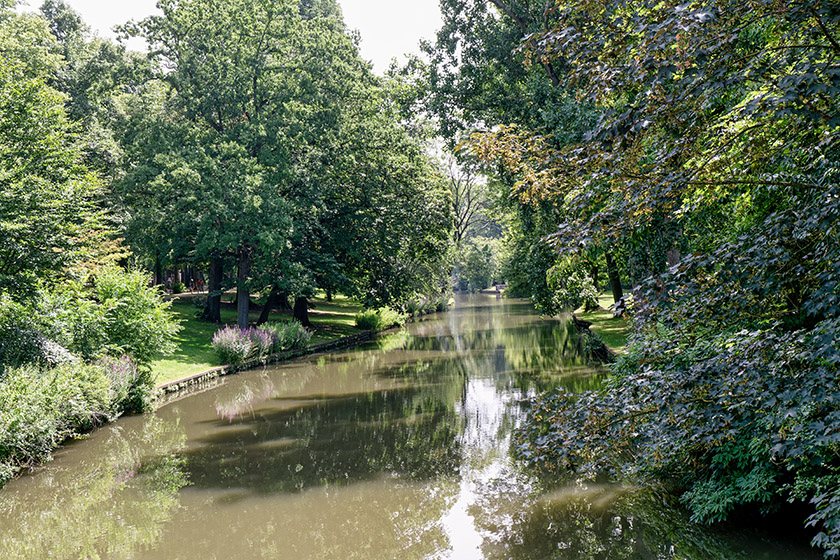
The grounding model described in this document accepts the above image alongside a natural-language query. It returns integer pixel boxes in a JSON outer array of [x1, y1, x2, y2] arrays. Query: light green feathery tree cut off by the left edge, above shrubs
[[0, 58, 105, 297]]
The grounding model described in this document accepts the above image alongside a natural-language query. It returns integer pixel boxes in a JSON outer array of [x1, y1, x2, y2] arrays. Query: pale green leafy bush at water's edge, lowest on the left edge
[[0, 363, 116, 485]]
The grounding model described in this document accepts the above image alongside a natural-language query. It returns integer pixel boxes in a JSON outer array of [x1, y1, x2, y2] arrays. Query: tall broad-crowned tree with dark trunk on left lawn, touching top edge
[[122, 0, 354, 326]]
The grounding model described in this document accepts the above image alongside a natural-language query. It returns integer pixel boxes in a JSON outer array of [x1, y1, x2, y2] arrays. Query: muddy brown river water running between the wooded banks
[[0, 296, 820, 560]]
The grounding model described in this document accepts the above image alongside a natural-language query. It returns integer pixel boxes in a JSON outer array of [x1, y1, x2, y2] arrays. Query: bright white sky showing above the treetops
[[16, 0, 441, 74]]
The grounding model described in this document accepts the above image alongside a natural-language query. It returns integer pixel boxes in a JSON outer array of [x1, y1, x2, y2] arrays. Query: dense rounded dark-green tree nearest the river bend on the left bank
[[322, 83, 452, 306]]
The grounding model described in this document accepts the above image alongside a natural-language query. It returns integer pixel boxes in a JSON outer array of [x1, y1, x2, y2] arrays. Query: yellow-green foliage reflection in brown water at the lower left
[[0, 416, 188, 560]]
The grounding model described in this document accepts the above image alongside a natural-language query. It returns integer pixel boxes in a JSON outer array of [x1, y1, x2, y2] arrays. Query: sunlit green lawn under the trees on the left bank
[[152, 295, 362, 385]]
